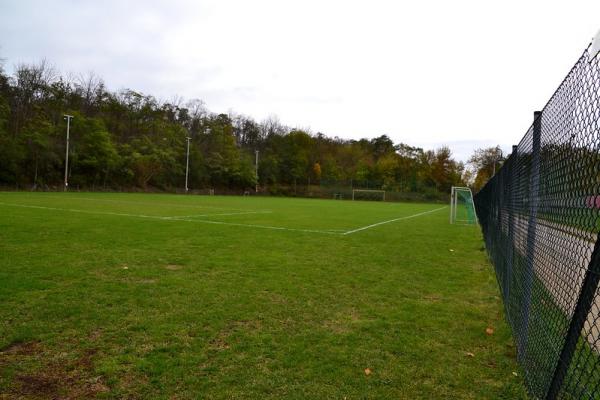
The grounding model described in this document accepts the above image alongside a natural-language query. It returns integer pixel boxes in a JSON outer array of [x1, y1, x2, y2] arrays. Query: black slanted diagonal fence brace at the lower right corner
[[546, 233, 600, 400]]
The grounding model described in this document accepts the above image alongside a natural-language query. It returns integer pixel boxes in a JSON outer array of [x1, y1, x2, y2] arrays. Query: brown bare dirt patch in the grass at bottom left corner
[[0, 341, 110, 400]]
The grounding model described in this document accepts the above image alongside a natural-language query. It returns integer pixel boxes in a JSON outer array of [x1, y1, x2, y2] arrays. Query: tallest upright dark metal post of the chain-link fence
[[519, 111, 542, 357]]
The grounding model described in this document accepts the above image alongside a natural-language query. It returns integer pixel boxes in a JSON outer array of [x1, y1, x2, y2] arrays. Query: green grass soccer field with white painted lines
[[0, 193, 525, 399]]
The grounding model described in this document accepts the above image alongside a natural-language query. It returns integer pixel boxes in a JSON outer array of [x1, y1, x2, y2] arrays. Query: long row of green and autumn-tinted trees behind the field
[[0, 61, 464, 194]]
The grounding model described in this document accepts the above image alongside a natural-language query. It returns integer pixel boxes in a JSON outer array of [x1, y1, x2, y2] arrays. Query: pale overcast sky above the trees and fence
[[0, 0, 600, 160]]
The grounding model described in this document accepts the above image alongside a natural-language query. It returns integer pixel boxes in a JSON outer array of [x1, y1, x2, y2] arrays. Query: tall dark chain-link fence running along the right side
[[475, 42, 600, 399]]
